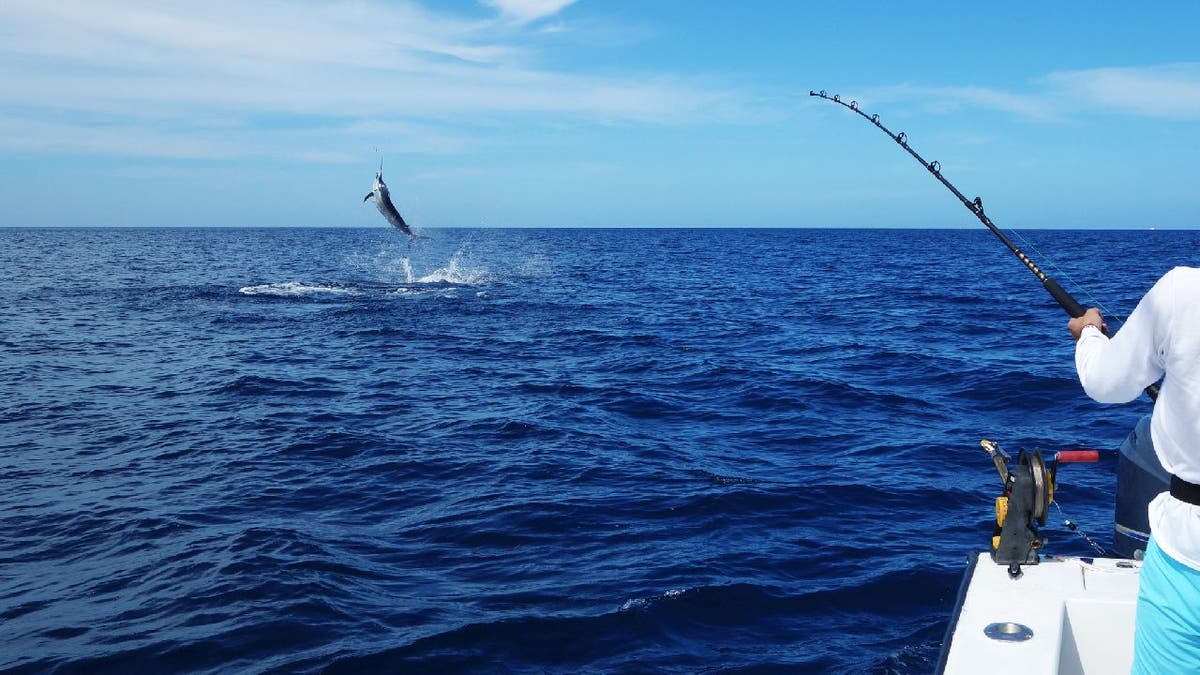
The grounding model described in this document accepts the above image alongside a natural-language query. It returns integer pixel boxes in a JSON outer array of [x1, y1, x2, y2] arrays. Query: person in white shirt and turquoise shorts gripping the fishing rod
[[1067, 267, 1200, 674]]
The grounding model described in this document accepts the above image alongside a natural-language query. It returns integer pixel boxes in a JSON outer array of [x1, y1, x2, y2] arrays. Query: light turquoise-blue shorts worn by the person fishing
[[1133, 537, 1200, 675]]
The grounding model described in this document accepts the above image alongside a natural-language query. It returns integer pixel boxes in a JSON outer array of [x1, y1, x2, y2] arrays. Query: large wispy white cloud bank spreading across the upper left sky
[[0, 0, 739, 157]]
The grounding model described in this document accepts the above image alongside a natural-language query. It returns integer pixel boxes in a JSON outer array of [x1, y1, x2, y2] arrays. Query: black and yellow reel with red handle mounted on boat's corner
[[979, 440, 1099, 578]]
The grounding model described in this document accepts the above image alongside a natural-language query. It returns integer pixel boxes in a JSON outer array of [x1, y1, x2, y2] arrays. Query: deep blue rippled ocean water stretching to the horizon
[[0, 228, 1200, 674]]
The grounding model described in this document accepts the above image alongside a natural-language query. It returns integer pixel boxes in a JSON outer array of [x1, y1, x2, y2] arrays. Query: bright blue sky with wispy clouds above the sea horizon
[[0, 0, 1200, 229]]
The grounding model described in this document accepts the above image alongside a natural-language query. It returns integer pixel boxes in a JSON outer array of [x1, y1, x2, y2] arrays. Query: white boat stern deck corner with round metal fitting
[[943, 552, 1141, 675]]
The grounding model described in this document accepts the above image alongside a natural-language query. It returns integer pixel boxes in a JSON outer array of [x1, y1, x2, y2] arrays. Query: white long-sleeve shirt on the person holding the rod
[[1075, 267, 1200, 569]]
